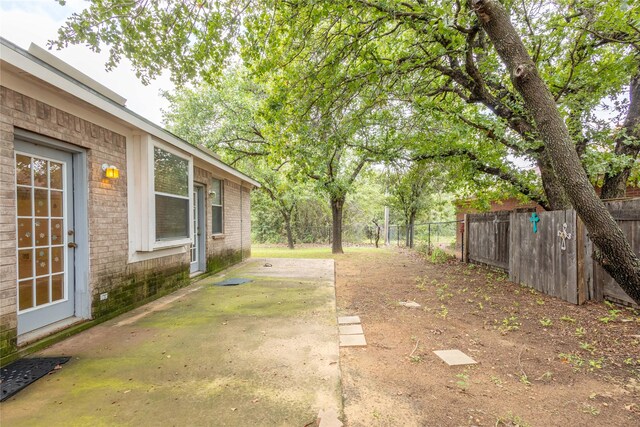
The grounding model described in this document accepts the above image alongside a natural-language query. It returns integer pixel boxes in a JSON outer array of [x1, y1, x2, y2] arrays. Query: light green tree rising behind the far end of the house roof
[[164, 66, 304, 249]]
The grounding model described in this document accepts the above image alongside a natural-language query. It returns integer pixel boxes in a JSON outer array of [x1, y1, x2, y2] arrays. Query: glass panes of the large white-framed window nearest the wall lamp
[[153, 147, 189, 241]]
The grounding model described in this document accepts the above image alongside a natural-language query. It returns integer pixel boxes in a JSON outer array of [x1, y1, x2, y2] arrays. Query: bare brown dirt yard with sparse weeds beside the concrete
[[335, 249, 640, 427]]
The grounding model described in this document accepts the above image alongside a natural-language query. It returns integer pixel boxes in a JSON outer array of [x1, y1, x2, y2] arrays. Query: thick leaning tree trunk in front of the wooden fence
[[469, 0, 640, 304]]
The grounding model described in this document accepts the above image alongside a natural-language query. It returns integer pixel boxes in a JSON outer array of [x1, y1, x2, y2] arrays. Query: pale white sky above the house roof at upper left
[[0, 0, 174, 125]]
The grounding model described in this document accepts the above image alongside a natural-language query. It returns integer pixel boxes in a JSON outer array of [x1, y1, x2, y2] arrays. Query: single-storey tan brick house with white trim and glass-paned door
[[0, 39, 259, 361]]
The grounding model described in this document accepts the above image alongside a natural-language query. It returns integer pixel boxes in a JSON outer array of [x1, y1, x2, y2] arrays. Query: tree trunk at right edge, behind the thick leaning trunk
[[600, 70, 640, 199]]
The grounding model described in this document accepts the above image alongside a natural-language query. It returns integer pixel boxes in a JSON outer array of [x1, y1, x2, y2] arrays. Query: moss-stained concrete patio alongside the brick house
[[0, 259, 342, 426]]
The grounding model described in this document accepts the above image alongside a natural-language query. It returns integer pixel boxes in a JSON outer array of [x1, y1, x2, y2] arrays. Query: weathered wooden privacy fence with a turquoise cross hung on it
[[464, 199, 640, 305]]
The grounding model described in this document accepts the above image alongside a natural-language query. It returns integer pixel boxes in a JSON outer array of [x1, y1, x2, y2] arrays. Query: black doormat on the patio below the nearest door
[[0, 357, 71, 402]]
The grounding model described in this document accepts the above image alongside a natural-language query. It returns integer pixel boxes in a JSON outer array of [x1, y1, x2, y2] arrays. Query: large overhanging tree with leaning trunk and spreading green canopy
[[52, 0, 640, 301]]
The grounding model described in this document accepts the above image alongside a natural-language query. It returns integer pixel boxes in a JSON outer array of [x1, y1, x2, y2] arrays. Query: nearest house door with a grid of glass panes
[[15, 146, 74, 334]]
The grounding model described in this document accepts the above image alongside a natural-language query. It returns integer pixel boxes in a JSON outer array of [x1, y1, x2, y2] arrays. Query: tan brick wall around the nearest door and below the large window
[[0, 87, 228, 355]]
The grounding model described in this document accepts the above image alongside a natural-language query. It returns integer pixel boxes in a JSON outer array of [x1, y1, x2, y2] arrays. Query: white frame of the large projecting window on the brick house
[[129, 134, 193, 252]]
